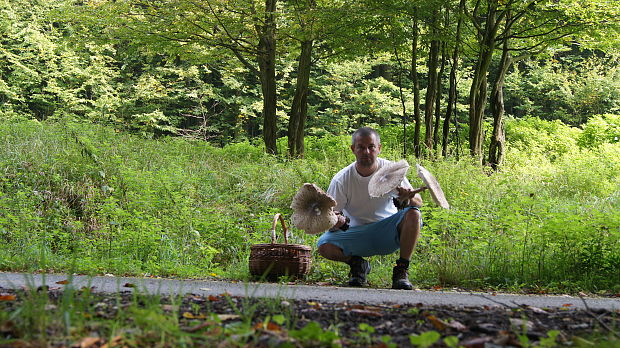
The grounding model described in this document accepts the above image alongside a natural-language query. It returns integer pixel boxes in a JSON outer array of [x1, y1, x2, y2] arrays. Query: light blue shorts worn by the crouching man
[[317, 207, 422, 256]]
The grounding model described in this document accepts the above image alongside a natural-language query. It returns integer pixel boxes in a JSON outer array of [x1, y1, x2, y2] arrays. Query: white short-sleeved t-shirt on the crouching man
[[327, 158, 412, 227]]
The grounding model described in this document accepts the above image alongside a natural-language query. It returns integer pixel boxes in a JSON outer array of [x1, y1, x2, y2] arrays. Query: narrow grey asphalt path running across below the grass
[[0, 273, 620, 311]]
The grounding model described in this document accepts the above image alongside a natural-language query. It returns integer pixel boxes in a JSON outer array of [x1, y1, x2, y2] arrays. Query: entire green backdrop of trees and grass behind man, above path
[[0, 0, 620, 293]]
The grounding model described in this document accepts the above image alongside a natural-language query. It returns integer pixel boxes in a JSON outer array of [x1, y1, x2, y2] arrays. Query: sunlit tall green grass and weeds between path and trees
[[0, 122, 620, 291]]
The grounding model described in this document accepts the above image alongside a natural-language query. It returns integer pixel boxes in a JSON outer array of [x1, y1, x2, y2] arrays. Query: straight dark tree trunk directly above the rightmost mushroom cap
[[424, 10, 439, 153]]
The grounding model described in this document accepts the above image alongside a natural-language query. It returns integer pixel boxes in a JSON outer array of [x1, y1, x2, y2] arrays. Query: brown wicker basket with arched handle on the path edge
[[250, 214, 312, 279]]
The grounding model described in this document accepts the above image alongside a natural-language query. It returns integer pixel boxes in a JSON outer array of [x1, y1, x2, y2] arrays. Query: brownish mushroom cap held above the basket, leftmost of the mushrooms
[[291, 183, 338, 234]]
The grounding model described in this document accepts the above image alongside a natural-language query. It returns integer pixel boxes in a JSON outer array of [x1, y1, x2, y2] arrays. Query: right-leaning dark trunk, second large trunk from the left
[[288, 40, 313, 157]]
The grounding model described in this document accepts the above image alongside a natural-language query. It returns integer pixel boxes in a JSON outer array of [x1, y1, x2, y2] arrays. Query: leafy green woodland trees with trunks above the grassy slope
[[0, 0, 620, 162]]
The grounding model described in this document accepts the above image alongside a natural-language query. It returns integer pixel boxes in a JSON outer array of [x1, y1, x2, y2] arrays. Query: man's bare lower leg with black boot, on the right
[[392, 208, 422, 290]]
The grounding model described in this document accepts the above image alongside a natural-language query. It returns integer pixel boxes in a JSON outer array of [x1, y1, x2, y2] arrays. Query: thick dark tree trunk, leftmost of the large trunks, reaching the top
[[257, 0, 278, 154]]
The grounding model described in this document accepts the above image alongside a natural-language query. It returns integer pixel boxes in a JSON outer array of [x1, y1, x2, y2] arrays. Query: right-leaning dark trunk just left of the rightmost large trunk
[[469, 1, 498, 163]]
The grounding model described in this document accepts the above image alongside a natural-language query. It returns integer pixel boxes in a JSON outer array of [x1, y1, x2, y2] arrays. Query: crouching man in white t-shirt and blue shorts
[[317, 127, 425, 290]]
